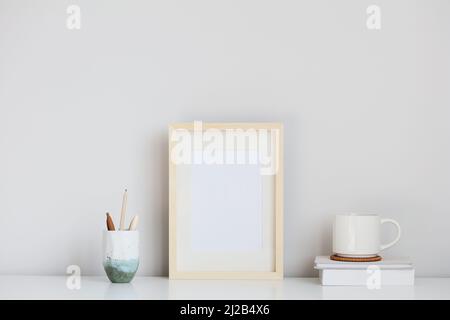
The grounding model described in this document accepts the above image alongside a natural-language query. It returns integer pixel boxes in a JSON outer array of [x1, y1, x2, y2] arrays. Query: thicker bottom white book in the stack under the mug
[[319, 268, 414, 288]]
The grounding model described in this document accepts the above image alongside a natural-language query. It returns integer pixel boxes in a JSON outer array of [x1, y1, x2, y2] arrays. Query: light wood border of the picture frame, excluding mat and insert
[[168, 122, 284, 280]]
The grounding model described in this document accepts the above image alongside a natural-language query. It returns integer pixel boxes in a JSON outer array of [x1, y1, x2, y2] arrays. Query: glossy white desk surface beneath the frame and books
[[0, 276, 450, 300]]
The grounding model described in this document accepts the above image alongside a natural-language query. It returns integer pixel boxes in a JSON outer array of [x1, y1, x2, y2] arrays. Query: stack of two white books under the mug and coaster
[[314, 256, 414, 286]]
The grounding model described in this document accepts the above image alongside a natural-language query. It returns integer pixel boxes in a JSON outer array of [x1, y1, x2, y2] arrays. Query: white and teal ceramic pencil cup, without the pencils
[[103, 230, 139, 283]]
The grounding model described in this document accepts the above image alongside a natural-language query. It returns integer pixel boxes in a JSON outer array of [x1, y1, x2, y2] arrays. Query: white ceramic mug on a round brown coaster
[[333, 213, 401, 257]]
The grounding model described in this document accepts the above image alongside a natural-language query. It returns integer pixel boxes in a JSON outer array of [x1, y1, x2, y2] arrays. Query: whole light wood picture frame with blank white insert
[[169, 122, 283, 279]]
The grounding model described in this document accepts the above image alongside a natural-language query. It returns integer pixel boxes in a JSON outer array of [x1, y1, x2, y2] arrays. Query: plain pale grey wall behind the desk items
[[0, 0, 450, 276]]
